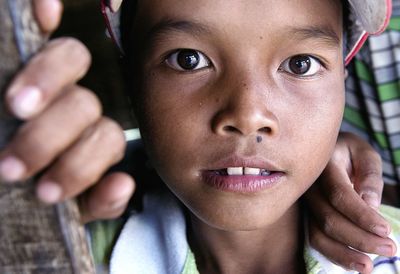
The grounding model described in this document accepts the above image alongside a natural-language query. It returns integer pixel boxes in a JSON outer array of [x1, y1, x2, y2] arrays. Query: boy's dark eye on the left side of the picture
[[166, 49, 210, 71]]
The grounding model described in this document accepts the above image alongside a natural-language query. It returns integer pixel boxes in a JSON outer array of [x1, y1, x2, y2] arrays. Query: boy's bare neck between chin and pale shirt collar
[[189, 204, 305, 274]]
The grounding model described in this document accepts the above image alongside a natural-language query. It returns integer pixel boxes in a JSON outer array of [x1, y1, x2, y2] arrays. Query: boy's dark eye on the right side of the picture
[[280, 55, 322, 76]]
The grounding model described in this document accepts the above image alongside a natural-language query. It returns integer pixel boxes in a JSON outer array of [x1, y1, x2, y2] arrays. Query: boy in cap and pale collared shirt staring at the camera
[[94, 0, 400, 273]]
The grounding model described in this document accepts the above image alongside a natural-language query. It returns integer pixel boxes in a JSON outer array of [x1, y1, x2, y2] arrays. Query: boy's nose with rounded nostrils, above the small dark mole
[[212, 76, 279, 136]]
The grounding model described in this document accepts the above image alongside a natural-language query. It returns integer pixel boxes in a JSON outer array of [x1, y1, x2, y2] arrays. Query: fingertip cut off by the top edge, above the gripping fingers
[[33, 0, 63, 33]]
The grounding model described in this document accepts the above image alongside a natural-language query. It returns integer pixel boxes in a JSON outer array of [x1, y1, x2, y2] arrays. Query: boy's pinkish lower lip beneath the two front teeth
[[203, 171, 284, 193]]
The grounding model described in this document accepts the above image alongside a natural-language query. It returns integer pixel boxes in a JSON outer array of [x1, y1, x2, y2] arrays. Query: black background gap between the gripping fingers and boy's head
[[54, 0, 136, 129]]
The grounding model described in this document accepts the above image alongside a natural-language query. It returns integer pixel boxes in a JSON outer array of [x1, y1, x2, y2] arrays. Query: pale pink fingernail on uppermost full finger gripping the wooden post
[[11, 86, 42, 119]]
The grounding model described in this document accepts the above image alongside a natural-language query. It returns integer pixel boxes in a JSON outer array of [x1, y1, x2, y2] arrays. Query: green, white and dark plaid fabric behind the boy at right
[[342, 0, 400, 185]]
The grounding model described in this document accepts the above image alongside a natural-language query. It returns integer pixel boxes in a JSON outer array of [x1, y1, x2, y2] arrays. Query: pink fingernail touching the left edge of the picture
[[0, 156, 26, 182]]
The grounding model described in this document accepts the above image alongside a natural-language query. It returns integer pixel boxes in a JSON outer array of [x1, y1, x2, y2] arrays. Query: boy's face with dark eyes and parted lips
[[135, 0, 344, 230]]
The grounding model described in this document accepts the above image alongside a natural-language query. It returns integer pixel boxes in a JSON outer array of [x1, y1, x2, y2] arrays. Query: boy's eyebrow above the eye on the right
[[289, 26, 340, 47]]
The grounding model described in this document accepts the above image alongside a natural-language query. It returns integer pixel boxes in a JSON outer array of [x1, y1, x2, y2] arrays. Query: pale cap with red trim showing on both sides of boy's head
[[101, 0, 392, 65]]
